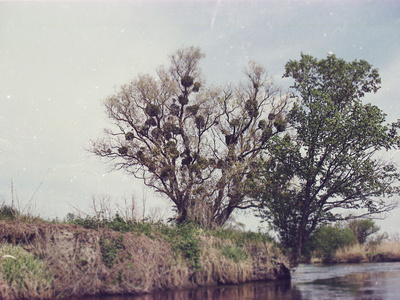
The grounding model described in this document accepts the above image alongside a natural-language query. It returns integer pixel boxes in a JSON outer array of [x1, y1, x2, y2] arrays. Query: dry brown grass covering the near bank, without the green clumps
[[0, 221, 287, 299]]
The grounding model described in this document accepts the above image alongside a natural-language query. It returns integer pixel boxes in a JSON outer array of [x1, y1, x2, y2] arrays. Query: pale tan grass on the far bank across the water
[[311, 241, 400, 263]]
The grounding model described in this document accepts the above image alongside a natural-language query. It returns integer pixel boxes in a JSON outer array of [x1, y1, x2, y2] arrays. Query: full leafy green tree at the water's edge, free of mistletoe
[[250, 54, 400, 262]]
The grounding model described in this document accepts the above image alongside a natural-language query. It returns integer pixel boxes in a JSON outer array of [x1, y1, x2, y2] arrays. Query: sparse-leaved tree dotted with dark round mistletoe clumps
[[92, 47, 287, 227]]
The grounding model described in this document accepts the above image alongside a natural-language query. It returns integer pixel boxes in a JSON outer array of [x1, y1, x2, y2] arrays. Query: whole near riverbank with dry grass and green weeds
[[0, 220, 290, 299]]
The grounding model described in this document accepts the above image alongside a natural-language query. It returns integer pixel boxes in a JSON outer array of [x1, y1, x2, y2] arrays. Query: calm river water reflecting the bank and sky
[[71, 263, 400, 300]]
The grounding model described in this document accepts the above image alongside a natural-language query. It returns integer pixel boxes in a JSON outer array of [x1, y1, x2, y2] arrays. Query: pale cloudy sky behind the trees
[[0, 0, 400, 234]]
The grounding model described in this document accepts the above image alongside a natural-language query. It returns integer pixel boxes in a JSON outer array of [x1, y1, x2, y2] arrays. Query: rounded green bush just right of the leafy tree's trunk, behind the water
[[306, 226, 357, 262]]
